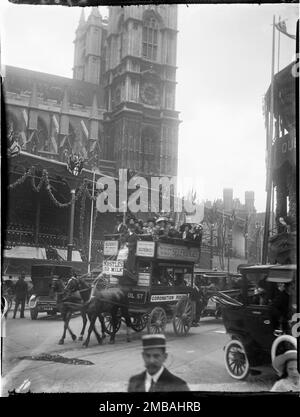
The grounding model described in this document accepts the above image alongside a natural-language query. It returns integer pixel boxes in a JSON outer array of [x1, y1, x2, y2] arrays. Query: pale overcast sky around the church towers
[[0, 0, 299, 212]]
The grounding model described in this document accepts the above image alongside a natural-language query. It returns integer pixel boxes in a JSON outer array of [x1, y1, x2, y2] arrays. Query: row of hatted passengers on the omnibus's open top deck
[[114, 215, 203, 243]]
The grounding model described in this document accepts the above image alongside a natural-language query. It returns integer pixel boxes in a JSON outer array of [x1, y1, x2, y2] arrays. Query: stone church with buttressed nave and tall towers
[[4, 5, 179, 176]]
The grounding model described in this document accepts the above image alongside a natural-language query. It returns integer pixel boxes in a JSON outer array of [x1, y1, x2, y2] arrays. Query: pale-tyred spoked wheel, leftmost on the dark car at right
[[225, 340, 250, 380]]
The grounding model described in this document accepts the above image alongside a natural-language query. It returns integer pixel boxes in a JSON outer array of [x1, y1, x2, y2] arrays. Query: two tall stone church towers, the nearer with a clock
[[73, 5, 179, 176]]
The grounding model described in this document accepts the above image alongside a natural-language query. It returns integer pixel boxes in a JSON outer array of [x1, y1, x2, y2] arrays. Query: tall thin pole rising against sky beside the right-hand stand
[[262, 15, 275, 264]]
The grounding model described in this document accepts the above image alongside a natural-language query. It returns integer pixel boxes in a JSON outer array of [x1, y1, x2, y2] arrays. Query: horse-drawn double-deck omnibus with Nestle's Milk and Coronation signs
[[103, 235, 200, 336]]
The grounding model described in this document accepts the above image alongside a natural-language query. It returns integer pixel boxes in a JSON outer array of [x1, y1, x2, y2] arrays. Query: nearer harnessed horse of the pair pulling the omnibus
[[83, 273, 131, 347]]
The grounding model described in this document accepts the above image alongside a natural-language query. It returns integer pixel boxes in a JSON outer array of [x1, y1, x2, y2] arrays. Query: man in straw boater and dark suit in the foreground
[[128, 334, 189, 392]]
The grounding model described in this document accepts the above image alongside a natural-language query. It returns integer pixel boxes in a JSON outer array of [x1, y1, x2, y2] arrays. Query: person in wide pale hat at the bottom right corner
[[271, 350, 300, 392]]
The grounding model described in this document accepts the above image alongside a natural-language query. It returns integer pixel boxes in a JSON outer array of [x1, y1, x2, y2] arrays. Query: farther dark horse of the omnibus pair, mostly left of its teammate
[[51, 277, 105, 345]]
